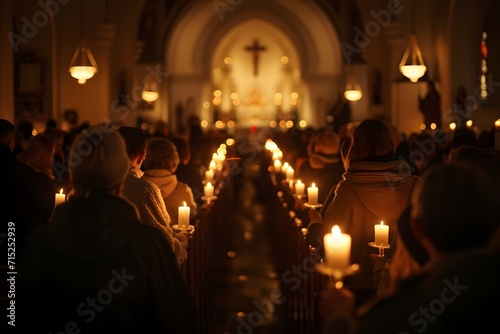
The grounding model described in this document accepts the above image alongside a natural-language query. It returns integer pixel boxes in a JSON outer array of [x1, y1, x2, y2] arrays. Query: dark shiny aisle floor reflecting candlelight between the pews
[[207, 157, 286, 334]]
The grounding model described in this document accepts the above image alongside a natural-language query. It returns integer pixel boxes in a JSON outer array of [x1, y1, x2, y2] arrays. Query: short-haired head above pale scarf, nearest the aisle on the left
[[144, 138, 179, 173]]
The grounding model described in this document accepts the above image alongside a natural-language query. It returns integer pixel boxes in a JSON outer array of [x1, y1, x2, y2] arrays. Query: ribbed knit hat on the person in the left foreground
[[68, 126, 130, 189]]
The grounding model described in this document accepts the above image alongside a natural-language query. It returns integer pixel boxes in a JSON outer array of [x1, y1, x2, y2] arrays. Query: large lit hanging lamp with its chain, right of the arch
[[399, 0, 427, 82]]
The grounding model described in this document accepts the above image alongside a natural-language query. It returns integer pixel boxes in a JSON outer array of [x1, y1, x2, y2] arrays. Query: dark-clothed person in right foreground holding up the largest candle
[[320, 164, 500, 334]]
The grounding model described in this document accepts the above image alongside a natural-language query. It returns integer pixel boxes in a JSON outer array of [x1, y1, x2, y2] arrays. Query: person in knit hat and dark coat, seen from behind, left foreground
[[16, 126, 196, 333]]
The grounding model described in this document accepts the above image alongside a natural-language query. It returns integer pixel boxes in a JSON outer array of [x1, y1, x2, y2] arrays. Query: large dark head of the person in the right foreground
[[410, 164, 498, 258]]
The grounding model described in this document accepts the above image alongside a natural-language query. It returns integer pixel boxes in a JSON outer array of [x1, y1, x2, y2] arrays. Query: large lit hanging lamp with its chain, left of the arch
[[69, 0, 98, 85]]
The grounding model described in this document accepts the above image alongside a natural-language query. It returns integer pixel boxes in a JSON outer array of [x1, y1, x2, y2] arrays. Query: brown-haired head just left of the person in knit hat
[[17, 134, 55, 179]]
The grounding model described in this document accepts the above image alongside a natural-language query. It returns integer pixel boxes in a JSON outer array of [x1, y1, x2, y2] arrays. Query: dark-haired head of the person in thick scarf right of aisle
[[346, 119, 395, 165]]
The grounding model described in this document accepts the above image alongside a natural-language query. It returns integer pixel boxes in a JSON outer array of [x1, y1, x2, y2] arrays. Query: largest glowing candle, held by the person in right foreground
[[323, 225, 351, 270]]
